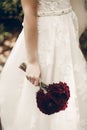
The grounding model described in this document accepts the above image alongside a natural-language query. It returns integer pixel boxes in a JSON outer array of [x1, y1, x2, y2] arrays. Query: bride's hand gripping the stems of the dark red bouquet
[[26, 61, 41, 86]]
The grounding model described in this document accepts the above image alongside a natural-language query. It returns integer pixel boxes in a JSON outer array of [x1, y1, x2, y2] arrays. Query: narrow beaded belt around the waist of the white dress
[[37, 7, 72, 17]]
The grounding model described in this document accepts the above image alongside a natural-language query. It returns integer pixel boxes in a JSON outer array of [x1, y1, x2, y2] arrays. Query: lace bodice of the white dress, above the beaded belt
[[38, 0, 71, 16]]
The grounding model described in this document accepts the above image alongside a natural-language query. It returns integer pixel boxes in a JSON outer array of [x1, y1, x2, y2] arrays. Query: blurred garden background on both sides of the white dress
[[0, 0, 87, 72]]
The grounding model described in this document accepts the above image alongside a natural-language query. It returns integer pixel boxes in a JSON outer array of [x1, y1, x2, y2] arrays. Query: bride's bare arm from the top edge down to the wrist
[[21, 0, 38, 62]]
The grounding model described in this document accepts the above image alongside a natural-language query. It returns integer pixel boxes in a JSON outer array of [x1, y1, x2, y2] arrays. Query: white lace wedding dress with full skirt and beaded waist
[[0, 0, 87, 130]]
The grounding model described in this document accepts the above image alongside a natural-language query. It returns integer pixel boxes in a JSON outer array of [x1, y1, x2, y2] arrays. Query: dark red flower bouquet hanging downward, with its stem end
[[19, 63, 70, 115]]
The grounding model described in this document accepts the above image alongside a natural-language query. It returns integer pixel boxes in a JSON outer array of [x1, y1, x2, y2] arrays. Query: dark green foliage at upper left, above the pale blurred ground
[[0, 0, 23, 44]]
